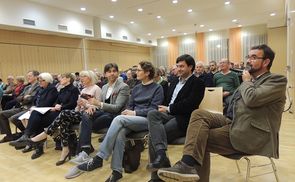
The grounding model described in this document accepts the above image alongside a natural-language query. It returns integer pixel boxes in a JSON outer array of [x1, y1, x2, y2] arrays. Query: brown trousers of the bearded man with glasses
[[183, 109, 244, 182]]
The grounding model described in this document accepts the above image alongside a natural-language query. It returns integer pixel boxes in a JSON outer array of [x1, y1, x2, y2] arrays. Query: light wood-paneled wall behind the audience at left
[[0, 29, 152, 80]]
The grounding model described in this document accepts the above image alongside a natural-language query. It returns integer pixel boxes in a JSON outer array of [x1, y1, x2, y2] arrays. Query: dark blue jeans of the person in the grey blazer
[[79, 110, 116, 147]]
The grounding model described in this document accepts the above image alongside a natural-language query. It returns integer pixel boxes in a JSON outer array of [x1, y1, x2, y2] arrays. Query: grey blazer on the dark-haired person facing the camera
[[101, 80, 129, 114]]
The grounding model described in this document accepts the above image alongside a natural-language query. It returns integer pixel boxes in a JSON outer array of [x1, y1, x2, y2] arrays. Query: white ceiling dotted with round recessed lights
[[28, 0, 285, 38]]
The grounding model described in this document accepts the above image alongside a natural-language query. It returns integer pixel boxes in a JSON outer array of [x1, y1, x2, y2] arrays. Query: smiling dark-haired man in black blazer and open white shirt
[[147, 54, 205, 181]]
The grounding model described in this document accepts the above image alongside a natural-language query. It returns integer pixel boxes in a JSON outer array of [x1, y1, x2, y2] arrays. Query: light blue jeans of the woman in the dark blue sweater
[[97, 115, 148, 173]]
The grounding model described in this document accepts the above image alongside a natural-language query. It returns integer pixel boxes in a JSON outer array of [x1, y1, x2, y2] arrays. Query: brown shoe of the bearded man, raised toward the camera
[[158, 161, 200, 182]]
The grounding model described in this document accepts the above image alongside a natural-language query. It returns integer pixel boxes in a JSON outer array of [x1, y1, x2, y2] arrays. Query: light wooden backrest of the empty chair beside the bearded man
[[199, 87, 223, 114]]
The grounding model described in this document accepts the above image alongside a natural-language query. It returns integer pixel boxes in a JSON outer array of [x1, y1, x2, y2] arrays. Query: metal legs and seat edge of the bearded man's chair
[[223, 154, 279, 182]]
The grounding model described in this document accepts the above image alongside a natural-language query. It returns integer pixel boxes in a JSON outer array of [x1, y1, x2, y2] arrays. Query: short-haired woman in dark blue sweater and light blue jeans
[[66, 61, 164, 181]]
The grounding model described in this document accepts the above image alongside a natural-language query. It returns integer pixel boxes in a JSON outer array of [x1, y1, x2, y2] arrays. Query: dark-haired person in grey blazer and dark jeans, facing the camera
[[72, 63, 129, 164]]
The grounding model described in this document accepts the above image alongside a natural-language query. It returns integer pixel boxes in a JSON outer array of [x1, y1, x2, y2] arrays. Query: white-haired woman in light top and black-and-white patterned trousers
[[30, 71, 101, 165]]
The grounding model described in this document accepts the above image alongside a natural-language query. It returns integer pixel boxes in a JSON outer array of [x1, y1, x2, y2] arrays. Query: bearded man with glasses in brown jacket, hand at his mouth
[[158, 45, 287, 181]]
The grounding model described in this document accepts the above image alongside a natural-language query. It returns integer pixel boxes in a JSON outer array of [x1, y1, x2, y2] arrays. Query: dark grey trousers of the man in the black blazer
[[147, 110, 185, 179]]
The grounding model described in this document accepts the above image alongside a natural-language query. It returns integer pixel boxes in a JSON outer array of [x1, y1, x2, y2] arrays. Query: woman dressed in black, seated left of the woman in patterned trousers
[[23, 73, 80, 159]]
